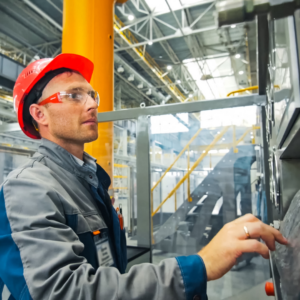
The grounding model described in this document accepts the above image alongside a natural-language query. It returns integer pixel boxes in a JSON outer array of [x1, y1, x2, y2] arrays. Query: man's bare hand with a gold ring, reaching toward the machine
[[198, 214, 288, 281]]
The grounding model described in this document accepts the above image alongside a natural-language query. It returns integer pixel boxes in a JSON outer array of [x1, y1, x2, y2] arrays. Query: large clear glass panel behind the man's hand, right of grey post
[[150, 106, 269, 299]]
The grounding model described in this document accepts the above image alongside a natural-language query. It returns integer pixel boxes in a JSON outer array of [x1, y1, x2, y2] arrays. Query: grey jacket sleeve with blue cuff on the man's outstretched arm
[[0, 178, 207, 300]]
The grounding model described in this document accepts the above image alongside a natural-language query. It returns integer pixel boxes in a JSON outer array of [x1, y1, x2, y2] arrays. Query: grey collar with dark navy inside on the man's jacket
[[38, 139, 110, 190]]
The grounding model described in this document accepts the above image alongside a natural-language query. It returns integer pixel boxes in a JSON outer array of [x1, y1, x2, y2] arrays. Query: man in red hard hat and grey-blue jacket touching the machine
[[0, 54, 287, 300]]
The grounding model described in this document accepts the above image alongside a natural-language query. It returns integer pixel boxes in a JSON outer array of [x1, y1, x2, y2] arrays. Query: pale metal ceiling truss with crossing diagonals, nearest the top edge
[[115, 0, 217, 52]]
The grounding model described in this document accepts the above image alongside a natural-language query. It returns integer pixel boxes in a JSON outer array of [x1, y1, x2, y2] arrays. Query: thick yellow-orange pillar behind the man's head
[[62, 0, 127, 190]]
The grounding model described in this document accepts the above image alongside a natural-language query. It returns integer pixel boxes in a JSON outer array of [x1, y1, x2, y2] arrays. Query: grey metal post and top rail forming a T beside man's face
[[98, 95, 266, 253]]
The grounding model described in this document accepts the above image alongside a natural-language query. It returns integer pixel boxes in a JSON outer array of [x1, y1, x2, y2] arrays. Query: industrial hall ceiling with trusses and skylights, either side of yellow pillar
[[0, 0, 257, 150]]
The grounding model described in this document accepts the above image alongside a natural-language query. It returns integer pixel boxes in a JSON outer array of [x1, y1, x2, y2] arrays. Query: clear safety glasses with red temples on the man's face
[[38, 91, 100, 106]]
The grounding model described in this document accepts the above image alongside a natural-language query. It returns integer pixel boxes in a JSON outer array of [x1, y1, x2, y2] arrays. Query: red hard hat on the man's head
[[13, 53, 94, 139]]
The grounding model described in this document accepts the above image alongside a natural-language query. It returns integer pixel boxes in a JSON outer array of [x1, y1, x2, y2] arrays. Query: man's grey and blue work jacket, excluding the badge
[[0, 139, 207, 300]]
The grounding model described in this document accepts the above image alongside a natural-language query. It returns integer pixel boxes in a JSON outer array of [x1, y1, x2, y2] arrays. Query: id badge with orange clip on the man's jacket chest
[[93, 231, 114, 267]]
